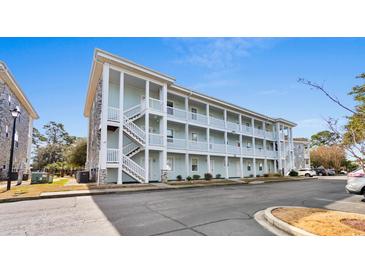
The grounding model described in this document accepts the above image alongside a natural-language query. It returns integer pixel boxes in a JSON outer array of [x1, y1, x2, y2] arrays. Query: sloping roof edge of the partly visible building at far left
[[0, 61, 39, 119]]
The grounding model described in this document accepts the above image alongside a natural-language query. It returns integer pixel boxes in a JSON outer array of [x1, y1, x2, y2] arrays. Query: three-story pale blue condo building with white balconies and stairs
[[84, 49, 296, 183]]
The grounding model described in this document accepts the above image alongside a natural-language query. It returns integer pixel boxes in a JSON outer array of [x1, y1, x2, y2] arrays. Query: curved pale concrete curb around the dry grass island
[[264, 206, 317, 236]]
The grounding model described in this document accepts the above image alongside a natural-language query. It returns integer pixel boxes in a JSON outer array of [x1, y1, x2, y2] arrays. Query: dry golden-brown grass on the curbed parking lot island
[[272, 208, 365, 236]]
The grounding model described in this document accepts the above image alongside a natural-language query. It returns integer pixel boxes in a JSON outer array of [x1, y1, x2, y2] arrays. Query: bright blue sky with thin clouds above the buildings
[[0, 38, 365, 137]]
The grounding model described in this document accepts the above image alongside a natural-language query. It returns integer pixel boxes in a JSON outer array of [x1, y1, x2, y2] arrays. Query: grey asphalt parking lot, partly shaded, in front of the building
[[0, 177, 365, 236]]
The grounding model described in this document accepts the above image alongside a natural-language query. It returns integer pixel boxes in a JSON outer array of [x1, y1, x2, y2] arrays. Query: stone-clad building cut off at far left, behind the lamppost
[[0, 61, 38, 180]]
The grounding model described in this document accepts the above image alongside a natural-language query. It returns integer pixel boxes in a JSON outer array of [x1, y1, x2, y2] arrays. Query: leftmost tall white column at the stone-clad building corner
[[98, 63, 109, 183]]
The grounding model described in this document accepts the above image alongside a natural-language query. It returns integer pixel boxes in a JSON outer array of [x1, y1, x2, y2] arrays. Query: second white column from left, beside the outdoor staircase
[[117, 72, 124, 184]]
